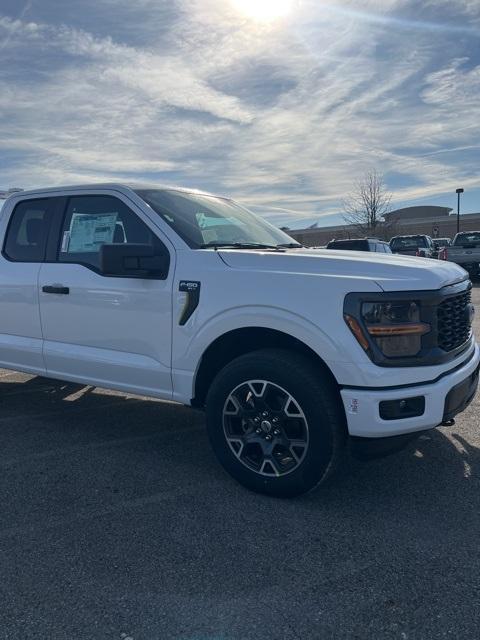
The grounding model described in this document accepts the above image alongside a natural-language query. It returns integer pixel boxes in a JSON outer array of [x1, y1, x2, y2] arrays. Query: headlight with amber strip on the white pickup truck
[[345, 301, 431, 358]]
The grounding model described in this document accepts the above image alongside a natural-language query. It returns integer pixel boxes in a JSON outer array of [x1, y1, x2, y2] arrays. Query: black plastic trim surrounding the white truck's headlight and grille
[[344, 277, 473, 367]]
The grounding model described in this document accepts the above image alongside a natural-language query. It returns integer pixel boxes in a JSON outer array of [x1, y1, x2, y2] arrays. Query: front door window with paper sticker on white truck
[[58, 196, 163, 271]]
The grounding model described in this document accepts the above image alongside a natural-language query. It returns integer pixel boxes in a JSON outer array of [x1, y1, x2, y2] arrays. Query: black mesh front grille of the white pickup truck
[[437, 290, 472, 351]]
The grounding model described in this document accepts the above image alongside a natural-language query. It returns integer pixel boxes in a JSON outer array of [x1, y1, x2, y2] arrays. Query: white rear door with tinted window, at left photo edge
[[0, 198, 54, 374]]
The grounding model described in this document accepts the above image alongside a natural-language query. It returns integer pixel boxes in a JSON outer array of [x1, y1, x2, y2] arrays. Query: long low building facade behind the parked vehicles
[[287, 206, 480, 247]]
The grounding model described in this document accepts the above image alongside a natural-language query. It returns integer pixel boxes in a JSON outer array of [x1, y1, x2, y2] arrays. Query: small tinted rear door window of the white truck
[[3, 198, 51, 262]]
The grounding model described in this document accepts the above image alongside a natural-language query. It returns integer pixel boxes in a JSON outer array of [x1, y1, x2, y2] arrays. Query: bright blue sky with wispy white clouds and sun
[[0, 0, 480, 229]]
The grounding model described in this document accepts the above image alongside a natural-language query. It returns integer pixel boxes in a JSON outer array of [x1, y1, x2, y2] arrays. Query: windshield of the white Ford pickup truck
[[135, 189, 301, 249]]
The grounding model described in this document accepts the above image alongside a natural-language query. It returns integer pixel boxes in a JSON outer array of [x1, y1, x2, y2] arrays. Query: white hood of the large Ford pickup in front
[[218, 249, 467, 291]]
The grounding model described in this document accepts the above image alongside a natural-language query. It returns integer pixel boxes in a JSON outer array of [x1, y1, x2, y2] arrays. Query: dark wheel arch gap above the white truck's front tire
[[191, 326, 339, 407]]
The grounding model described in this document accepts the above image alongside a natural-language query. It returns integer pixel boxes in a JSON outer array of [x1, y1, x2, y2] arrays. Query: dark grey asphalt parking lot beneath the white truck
[[0, 285, 480, 640]]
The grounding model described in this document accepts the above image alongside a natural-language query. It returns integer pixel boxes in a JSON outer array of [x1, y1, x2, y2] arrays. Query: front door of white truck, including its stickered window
[[39, 195, 174, 398]]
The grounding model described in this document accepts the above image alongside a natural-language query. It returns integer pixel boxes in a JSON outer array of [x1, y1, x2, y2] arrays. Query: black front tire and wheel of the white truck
[[206, 349, 347, 497]]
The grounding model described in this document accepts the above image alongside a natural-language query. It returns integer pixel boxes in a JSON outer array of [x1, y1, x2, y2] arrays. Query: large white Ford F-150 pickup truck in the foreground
[[0, 184, 479, 496]]
